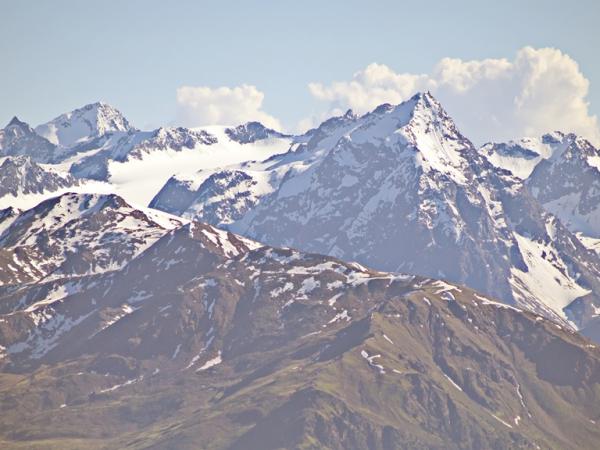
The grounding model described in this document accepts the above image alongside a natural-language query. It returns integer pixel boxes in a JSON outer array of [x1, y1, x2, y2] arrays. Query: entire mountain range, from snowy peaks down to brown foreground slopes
[[0, 93, 600, 450]]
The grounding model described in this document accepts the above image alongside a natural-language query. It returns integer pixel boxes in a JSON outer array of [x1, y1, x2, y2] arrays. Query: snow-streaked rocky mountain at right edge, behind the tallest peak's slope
[[482, 132, 600, 248]]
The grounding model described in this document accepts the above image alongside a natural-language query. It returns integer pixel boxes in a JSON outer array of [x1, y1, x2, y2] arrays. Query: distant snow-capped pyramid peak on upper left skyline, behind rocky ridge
[[35, 102, 134, 147]]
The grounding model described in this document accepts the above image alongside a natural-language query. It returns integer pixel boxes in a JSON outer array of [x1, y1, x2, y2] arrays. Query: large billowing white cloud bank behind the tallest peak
[[309, 47, 600, 144]]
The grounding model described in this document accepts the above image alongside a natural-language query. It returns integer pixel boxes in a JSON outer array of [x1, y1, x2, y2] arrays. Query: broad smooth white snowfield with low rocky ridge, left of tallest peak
[[71, 126, 291, 204]]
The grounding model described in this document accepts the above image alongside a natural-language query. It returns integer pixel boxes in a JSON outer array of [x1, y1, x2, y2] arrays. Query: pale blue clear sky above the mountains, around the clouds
[[0, 0, 600, 142]]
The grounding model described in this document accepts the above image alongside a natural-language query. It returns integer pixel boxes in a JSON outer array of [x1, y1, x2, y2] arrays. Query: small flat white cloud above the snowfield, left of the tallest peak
[[177, 84, 281, 130]]
